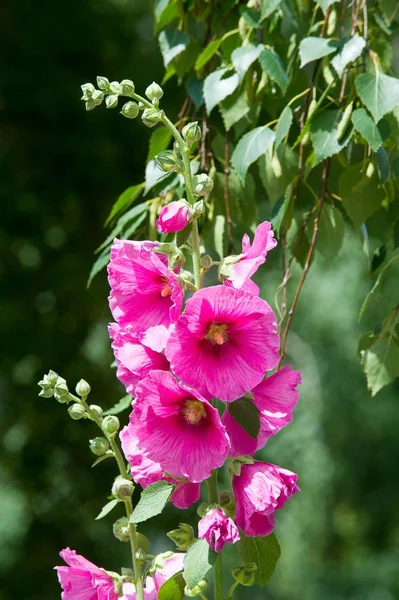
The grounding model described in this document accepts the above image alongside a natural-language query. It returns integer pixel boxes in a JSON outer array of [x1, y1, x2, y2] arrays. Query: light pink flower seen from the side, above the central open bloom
[[220, 221, 277, 295]]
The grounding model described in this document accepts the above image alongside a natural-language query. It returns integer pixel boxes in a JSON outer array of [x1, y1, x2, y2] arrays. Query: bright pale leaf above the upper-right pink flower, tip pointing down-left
[[231, 127, 276, 183]]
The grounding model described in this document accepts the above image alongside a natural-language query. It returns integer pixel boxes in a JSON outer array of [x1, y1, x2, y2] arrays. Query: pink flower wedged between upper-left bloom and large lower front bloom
[[108, 323, 169, 396]]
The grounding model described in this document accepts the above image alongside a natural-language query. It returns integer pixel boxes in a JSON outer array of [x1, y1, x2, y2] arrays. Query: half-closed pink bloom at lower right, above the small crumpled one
[[233, 461, 300, 536]]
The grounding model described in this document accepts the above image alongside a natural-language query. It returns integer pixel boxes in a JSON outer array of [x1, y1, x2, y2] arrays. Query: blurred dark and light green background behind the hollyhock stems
[[0, 0, 399, 600]]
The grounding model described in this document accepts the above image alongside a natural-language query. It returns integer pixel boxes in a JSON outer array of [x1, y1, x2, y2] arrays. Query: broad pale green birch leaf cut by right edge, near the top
[[355, 71, 399, 123]]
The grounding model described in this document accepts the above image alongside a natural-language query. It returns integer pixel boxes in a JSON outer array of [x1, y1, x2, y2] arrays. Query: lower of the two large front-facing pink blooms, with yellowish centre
[[128, 371, 229, 483]]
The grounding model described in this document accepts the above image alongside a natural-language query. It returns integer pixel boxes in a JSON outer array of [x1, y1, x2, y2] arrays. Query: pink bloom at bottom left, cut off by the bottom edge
[[55, 548, 118, 600]]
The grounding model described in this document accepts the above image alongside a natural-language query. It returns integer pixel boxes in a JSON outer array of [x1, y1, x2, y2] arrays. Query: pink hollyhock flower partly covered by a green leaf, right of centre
[[222, 365, 302, 456]]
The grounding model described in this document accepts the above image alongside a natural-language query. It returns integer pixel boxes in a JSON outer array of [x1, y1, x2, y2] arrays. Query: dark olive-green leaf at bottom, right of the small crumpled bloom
[[237, 531, 281, 587]]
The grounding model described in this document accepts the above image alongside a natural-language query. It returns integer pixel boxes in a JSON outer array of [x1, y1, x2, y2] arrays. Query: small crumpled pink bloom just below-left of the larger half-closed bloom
[[198, 508, 240, 552]]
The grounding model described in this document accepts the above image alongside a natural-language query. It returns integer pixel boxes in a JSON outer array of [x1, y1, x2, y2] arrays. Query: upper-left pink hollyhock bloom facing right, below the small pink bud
[[108, 239, 183, 335]]
